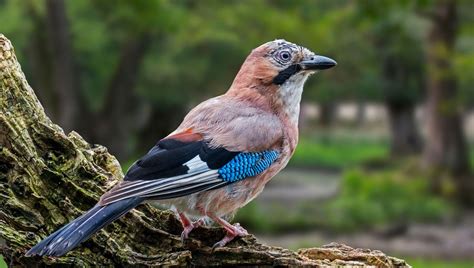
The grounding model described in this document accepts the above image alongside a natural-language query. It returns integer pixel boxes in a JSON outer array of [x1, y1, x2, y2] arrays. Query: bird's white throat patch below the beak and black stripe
[[279, 72, 310, 124]]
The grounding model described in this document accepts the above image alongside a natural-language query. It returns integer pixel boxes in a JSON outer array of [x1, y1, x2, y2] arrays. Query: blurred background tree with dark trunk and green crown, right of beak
[[359, 1, 426, 156]]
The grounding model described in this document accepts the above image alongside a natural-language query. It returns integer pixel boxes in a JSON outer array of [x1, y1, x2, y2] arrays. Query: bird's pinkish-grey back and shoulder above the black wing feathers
[[171, 95, 284, 152]]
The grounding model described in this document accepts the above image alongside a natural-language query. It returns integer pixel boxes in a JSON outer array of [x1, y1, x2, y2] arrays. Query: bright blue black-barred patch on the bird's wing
[[218, 150, 278, 182]]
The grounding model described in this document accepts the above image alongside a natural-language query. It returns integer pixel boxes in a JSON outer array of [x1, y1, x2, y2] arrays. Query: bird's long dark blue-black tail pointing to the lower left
[[26, 197, 143, 256]]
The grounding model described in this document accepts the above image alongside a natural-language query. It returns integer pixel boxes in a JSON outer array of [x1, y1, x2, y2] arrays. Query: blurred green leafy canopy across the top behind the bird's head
[[0, 0, 474, 113]]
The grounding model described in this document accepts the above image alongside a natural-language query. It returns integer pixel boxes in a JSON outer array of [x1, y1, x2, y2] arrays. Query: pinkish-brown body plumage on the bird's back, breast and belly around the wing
[[167, 95, 298, 217]]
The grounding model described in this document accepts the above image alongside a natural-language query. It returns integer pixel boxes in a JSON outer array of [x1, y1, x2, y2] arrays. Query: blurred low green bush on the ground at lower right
[[322, 168, 454, 230]]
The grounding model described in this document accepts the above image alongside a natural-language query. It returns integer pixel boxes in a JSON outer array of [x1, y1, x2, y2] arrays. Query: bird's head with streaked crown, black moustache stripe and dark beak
[[229, 39, 336, 121]]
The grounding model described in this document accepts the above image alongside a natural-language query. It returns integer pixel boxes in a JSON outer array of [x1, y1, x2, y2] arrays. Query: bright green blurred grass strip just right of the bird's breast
[[289, 131, 389, 169]]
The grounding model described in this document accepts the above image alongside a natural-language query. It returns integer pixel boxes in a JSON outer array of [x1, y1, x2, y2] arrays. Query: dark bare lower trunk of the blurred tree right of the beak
[[387, 103, 421, 157]]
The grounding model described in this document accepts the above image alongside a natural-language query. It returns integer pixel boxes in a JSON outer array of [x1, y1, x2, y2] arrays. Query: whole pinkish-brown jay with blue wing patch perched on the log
[[26, 39, 337, 256]]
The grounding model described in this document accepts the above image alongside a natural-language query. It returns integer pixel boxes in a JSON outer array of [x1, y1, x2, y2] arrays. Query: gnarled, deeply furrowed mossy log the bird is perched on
[[0, 34, 407, 267]]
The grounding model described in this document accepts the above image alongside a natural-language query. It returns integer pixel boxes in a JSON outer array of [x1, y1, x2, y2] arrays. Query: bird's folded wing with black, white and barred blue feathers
[[99, 130, 279, 205]]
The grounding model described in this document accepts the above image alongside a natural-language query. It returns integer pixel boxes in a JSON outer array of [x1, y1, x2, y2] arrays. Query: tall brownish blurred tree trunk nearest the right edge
[[424, 0, 474, 200]]
